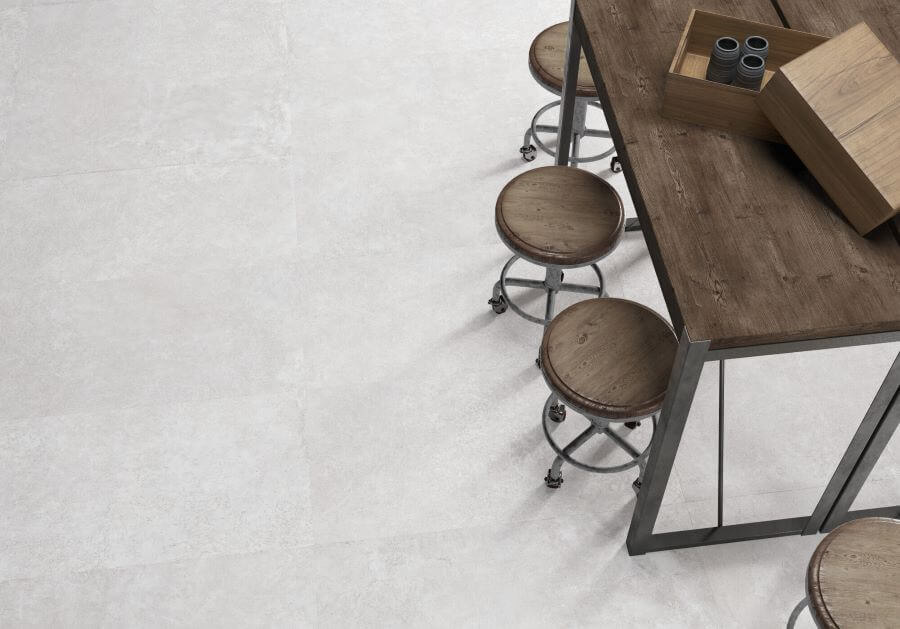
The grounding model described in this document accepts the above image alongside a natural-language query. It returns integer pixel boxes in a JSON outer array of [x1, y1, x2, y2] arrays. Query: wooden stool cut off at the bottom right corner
[[787, 518, 900, 629]]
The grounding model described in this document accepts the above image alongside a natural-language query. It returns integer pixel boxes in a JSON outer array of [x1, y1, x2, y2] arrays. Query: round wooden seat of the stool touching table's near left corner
[[541, 297, 678, 420]]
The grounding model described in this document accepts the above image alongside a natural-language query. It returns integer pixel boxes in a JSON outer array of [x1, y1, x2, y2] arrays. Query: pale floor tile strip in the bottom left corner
[[0, 550, 319, 628]]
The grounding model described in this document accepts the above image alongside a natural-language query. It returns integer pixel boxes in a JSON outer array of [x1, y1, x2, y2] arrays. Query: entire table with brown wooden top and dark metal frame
[[557, 0, 900, 554]]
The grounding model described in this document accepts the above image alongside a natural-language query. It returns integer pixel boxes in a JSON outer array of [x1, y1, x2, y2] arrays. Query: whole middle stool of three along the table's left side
[[488, 166, 625, 346]]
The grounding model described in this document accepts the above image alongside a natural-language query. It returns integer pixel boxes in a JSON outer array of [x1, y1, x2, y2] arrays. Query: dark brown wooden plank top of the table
[[577, 0, 900, 349]]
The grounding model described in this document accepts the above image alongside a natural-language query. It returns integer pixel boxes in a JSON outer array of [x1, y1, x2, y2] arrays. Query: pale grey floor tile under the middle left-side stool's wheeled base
[[298, 243, 619, 386]]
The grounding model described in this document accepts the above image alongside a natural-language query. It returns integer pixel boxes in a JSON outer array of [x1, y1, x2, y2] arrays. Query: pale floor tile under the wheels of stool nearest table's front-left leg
[[306, 360, 689, 543]]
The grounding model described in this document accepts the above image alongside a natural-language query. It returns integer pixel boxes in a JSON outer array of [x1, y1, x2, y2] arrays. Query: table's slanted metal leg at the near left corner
[[626, 330, 709, 555]]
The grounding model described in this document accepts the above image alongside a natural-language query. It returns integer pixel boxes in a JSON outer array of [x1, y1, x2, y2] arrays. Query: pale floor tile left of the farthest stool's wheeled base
[[292, 39, 624, 257]]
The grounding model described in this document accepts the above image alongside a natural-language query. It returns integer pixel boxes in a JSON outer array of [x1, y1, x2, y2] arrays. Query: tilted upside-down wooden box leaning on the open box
[[759, 24, 900, 234]]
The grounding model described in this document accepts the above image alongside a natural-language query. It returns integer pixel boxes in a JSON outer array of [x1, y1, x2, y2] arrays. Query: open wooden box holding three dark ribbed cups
[[663, 9, 828, 142]]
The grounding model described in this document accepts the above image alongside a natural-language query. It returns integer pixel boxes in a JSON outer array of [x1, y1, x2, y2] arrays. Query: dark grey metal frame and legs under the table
[[556, 0, 900, 555]]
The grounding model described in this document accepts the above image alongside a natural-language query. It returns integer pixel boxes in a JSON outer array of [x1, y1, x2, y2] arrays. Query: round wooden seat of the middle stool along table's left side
[[496, 166, 625, 266]]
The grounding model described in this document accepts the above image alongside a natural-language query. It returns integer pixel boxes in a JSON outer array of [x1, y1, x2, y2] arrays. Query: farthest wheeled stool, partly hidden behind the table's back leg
[[519, 22, 622, 172]]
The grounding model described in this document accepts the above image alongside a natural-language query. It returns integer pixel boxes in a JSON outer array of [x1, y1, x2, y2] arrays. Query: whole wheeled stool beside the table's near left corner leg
[[540, 297, 678, 491]]
